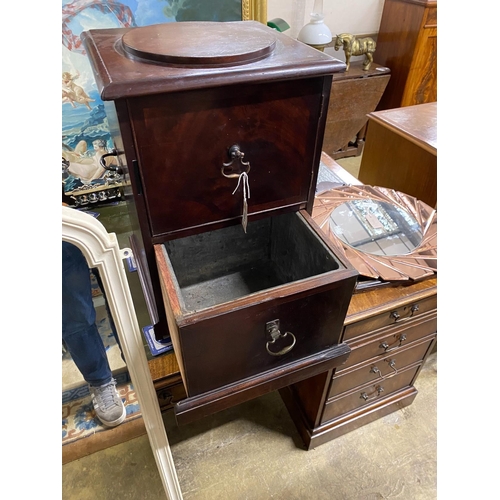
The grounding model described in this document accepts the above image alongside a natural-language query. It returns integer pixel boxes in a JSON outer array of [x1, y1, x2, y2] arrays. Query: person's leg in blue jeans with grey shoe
[[62, 242, 126, 427]]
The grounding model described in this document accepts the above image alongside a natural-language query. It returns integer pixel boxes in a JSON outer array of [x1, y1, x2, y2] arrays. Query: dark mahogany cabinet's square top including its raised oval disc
[[81, 21, 345, 101]]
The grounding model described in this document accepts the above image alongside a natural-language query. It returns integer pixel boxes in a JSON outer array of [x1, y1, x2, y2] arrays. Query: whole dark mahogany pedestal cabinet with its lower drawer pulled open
[[82, 21, 358, 423]]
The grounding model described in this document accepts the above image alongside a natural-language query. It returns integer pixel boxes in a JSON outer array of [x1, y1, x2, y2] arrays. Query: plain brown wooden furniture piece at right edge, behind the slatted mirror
[[358, 102, 437, 207]]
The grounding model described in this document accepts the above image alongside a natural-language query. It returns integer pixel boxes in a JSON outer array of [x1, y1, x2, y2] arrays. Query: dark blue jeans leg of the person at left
[[62, 241, 114, 386]]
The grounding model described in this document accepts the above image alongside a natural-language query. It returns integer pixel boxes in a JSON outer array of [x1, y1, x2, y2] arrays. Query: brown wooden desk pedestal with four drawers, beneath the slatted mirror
[[280, 278, 437, 449]]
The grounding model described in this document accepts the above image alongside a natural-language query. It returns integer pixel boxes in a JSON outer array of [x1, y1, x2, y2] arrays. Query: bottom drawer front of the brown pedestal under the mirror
[[321, 364, 420, 423]]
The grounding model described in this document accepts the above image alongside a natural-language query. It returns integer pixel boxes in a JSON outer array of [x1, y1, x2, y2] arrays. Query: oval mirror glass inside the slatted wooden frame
[[329, 199, 423, 256]]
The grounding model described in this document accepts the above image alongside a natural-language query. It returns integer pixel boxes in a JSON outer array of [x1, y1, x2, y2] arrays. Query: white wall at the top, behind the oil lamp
[[267, 0, 384, 38]]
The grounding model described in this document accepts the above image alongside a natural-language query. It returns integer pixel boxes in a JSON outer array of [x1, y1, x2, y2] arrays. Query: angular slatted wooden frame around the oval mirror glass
[[312, 184, 437, 282]]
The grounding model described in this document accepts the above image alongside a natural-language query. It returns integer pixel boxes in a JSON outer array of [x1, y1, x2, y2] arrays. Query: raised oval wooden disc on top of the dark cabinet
[[122, 21, 276, 67]]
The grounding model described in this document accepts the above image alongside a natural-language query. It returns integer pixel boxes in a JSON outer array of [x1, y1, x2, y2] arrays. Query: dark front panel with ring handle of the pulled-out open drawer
[[179, 287, 354, 397]]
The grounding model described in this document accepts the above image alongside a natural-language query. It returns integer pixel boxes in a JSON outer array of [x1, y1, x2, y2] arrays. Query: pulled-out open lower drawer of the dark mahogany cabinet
[[155, 212, 357, 397]]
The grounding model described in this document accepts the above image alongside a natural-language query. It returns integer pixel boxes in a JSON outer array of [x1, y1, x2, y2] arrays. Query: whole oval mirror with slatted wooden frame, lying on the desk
[[312, 184, 437, 288]]
